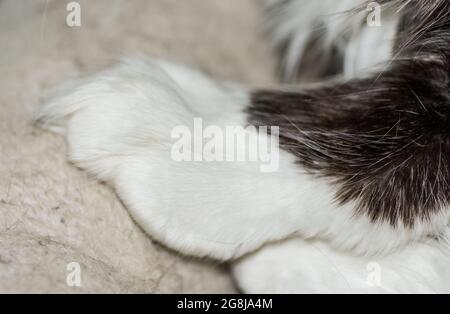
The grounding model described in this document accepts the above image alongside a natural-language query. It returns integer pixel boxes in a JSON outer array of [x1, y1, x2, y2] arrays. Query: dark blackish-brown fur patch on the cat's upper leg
[[247, 0, 450, 226]]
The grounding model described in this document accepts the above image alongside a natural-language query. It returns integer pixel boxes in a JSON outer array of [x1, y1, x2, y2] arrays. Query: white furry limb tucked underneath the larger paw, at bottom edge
[[233, 239, 450, 293]]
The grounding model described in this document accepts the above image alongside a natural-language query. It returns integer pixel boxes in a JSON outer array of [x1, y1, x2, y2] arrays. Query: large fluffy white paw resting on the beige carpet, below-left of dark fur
[[38, 60, 293, 259]]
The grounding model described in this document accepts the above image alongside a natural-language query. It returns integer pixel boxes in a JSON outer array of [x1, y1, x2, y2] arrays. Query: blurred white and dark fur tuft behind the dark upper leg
[[267, 0, 398, 82]]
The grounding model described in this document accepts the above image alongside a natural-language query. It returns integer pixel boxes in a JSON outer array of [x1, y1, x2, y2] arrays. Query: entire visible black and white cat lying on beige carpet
[[38, 0, 450, 293]]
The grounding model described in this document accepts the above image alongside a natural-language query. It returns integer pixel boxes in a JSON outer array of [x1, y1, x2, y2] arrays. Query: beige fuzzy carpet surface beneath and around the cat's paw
[[0, 0, 273, 293]]
